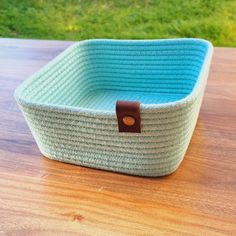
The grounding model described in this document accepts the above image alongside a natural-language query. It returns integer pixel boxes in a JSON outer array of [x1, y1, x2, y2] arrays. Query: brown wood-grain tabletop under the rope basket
[[0, 39, 236, 235]]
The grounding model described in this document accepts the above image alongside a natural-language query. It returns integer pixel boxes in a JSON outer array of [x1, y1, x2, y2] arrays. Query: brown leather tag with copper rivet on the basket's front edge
[[116, 101, 141, 133]]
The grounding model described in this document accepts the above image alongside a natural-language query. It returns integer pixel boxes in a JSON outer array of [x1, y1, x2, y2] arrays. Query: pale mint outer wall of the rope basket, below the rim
[[17, 89, 201, 176]]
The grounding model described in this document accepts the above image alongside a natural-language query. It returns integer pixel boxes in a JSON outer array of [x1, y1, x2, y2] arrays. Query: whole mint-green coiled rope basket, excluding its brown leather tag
[[15, 39, 213, 176]]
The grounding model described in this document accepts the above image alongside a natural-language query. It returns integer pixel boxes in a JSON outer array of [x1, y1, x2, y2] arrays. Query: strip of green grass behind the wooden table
[[0, 0, 236, 47]]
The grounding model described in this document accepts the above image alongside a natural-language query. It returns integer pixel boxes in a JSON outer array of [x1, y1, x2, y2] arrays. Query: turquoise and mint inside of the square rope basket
[[17, 39, 208, 110]]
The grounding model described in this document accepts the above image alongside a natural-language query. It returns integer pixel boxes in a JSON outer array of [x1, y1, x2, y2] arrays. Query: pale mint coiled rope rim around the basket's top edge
[[14, 38, 214, 117]]
